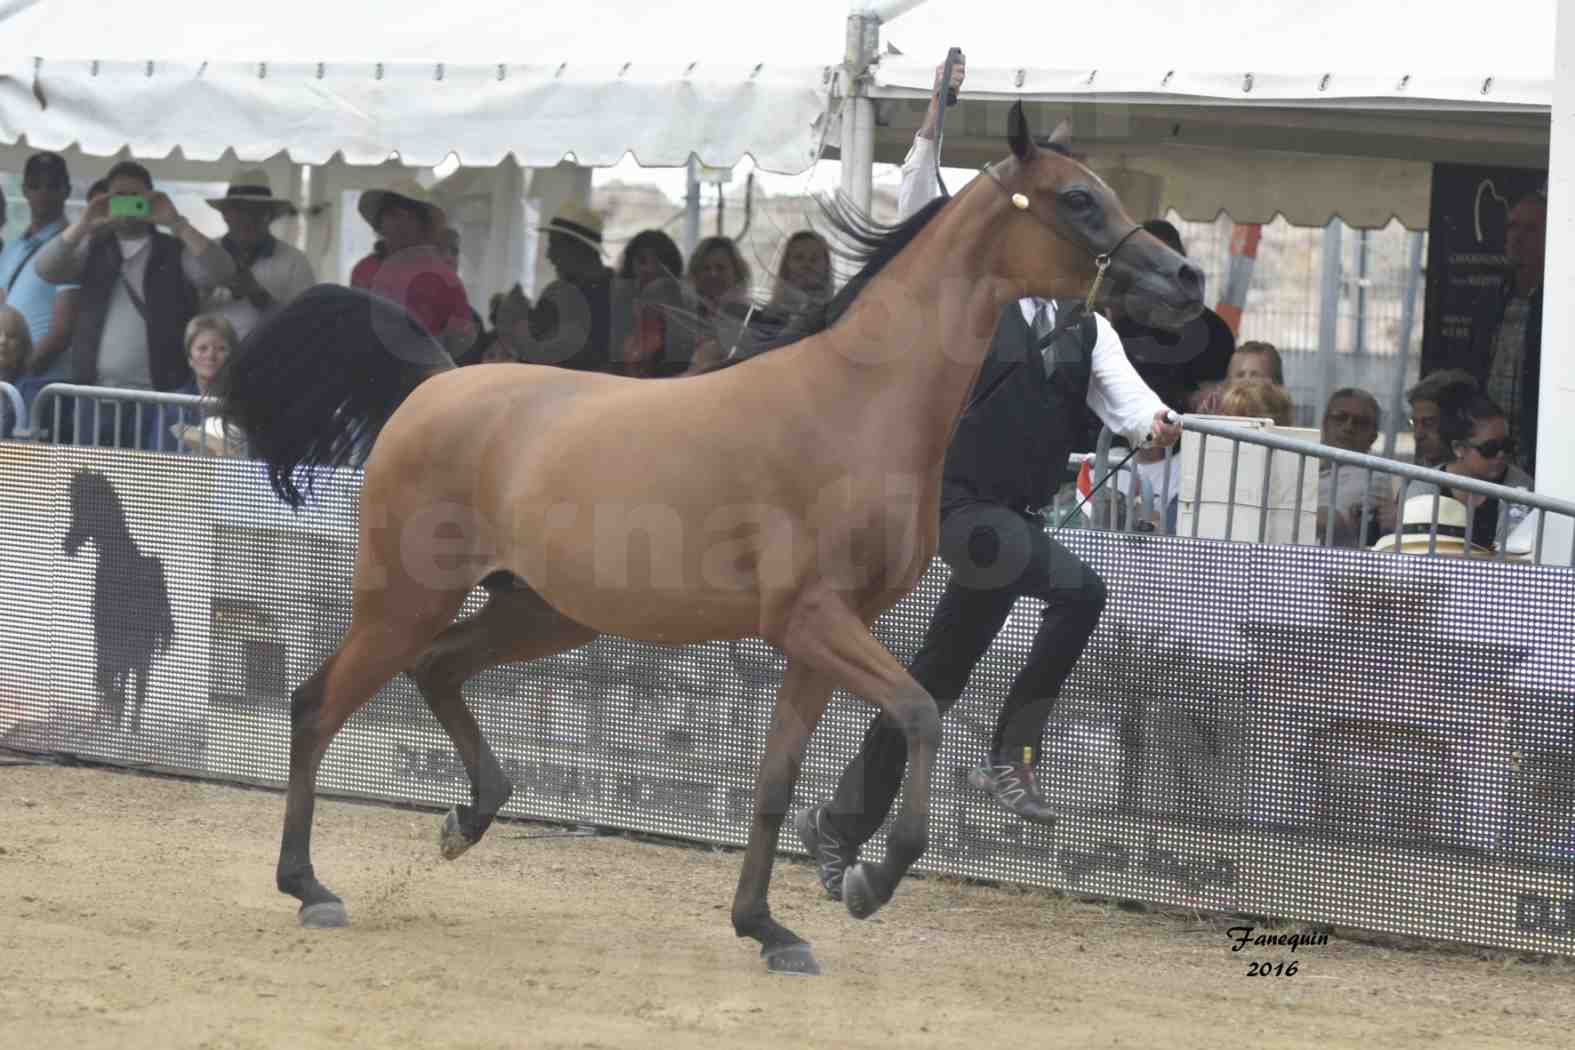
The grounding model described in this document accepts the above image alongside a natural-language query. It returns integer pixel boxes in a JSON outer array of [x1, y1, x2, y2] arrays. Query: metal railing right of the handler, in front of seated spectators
[[1093, 416, 1575, 564]]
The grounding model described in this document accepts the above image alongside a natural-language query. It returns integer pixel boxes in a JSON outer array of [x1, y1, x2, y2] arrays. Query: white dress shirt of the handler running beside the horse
[[896, 135, 1166, 447]]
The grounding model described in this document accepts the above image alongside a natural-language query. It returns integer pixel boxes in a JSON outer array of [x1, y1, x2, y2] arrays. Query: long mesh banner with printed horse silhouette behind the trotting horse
[[0, 444, 1575, 954]]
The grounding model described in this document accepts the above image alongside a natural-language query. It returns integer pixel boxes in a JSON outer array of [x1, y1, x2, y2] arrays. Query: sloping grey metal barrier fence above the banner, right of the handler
[[1093, 416, 1575, 564]]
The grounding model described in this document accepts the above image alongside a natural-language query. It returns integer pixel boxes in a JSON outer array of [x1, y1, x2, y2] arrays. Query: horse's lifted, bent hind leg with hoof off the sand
[[410, 587, 597, 861]]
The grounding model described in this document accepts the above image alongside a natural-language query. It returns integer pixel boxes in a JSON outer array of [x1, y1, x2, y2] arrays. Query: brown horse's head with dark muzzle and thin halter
[[986, 102, 1203, 326]]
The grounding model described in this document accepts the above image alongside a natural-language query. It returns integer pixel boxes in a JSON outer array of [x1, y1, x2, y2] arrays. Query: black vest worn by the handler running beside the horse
[[940, 299, 1098, 512]]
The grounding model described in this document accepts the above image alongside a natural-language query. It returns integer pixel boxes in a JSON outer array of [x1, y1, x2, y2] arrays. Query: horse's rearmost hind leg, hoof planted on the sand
[[277, 590, 465, 926]]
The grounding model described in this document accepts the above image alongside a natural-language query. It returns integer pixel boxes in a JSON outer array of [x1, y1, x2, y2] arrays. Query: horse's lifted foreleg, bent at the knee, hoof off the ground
[[771, 595, 940, 919]]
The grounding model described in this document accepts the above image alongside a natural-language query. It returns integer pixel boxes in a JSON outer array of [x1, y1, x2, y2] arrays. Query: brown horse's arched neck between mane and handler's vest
[[828, 187, 1022, 469]]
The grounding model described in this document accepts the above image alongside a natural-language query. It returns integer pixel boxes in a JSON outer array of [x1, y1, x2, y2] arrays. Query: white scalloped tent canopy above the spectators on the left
[[0, 0, 846, 173]]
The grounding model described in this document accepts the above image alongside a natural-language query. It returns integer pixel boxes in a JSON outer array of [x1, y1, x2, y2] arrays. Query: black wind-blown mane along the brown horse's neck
[[704, 197, 950, 372]]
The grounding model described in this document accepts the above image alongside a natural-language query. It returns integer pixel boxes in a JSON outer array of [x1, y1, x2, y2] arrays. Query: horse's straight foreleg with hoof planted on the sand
[[732, 660, 832, 974]]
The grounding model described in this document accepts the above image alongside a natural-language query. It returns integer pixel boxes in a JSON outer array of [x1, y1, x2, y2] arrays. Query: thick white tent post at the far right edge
[[1537, 3, 1575, 560]]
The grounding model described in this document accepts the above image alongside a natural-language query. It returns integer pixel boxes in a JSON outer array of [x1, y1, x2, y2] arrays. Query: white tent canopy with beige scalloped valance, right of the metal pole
[[850, 0, 1555, 228]]
